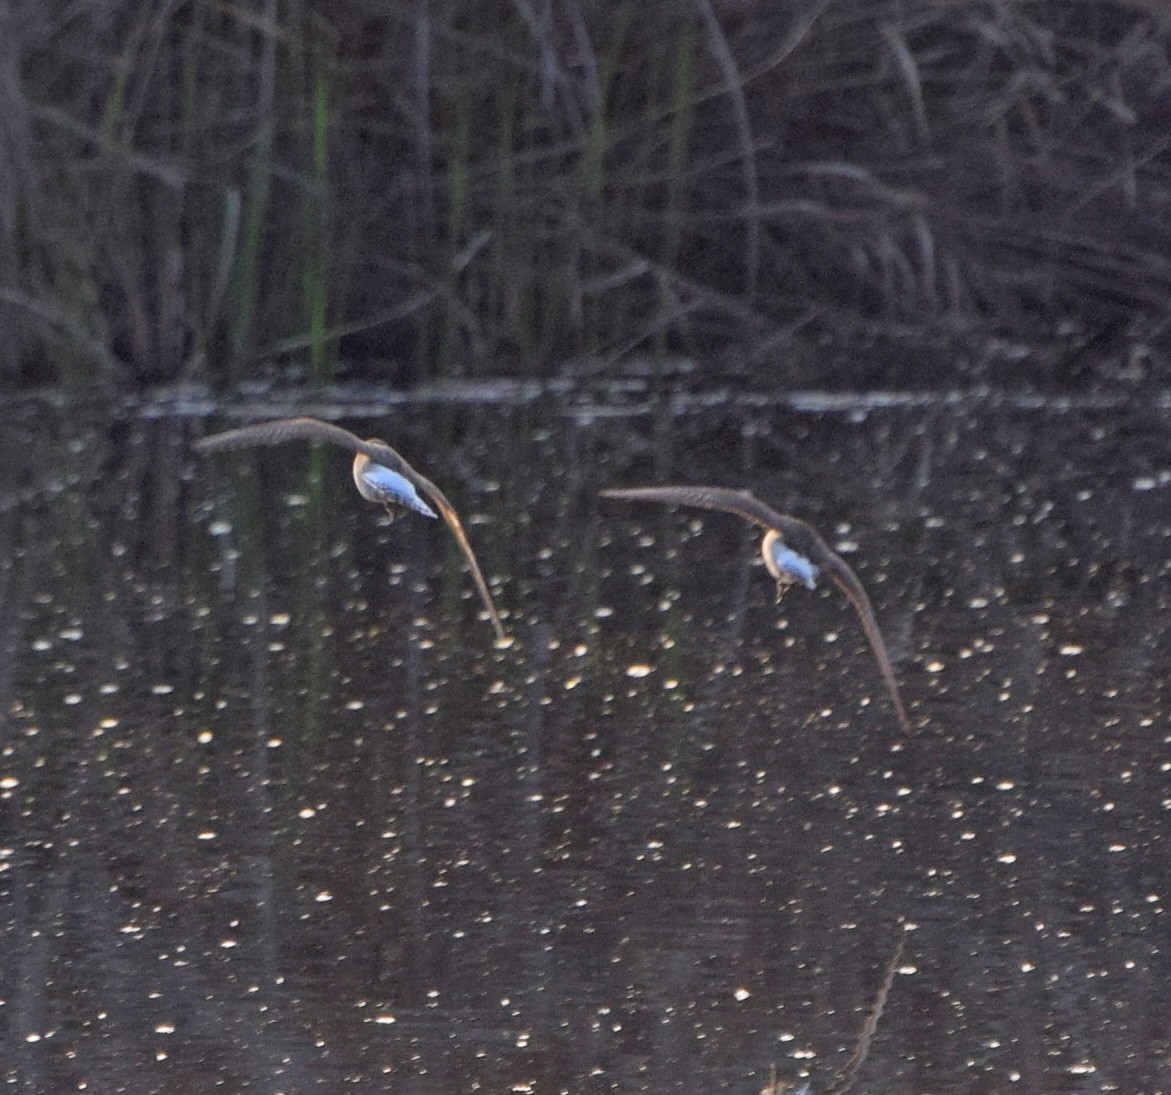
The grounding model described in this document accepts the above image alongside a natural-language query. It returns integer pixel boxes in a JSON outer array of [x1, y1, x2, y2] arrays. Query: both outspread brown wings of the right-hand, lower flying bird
[[602, 486, 911, 732]]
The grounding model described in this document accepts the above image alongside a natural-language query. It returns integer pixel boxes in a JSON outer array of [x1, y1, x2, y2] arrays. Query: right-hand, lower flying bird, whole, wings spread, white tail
[[602, 487, 911, 732]]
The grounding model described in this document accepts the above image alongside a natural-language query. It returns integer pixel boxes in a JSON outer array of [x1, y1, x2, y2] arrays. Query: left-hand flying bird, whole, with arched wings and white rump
[[193, 418, 505, 639]]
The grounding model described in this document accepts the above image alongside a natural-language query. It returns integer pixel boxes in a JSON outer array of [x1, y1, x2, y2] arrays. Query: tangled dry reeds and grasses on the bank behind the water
[[0, 0, 1171, 388]]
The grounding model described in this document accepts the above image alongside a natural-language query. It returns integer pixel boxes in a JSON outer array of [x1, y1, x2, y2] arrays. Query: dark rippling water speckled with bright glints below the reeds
[[0, 397, 1171, 1095]]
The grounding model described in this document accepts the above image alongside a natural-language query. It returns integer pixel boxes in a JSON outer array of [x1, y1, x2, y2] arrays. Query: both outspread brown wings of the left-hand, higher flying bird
[[192, 418, 505, 638]]
